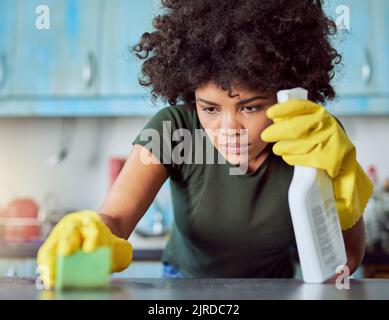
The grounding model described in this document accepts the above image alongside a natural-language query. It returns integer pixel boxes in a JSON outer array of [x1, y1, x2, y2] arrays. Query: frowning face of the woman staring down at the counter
[[195, 82, 277, 169]]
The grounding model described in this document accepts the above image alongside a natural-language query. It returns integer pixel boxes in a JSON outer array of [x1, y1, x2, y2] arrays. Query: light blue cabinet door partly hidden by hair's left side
[[101, 0, 160, 96]]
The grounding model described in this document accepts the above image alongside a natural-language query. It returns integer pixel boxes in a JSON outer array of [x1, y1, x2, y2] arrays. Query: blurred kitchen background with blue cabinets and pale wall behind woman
[[0, 0, 389, 278]]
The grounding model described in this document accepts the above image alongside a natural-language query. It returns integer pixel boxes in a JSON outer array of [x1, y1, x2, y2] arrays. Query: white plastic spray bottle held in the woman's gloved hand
[[277, 88, 347, 283]]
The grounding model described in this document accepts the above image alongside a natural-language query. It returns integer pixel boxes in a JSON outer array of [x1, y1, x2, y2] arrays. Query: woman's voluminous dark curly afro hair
[[132, 0, 341, 105]]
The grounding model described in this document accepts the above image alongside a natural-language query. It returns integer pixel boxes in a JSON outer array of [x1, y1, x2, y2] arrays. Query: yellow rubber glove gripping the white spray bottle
[[261, 100, 373, 230]]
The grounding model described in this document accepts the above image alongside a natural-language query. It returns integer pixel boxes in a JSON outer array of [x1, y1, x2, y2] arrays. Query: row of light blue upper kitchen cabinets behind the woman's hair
[[0, 0, 389, 117]]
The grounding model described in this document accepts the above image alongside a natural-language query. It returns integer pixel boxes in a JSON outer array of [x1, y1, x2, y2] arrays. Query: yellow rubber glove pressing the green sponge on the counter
[[37, 211, 132, 288]]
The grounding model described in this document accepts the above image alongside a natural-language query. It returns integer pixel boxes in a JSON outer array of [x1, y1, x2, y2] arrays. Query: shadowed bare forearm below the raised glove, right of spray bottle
[[343, 216, 365, 275]]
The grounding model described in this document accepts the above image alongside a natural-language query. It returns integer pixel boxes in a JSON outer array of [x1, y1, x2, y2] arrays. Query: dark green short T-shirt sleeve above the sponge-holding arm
[[132, 107, 177, 175]]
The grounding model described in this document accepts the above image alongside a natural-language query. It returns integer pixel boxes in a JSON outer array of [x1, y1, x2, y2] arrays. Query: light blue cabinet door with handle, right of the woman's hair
[[325, 0, 378, 96]]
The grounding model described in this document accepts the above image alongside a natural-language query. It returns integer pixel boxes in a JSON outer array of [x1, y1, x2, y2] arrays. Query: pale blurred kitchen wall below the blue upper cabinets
[[0, 117, 389, 212]]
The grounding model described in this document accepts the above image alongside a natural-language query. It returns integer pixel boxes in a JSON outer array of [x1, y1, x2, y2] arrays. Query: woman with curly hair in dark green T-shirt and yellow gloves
[[38, 0, 372, 285]]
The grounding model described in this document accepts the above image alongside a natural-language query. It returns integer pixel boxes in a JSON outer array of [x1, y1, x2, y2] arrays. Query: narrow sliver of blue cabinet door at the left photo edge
[[0, 0, 16, 97]]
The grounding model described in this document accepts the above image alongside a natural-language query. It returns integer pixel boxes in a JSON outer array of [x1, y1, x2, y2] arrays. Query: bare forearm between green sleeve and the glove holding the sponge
[[98, 144, 168, 239]]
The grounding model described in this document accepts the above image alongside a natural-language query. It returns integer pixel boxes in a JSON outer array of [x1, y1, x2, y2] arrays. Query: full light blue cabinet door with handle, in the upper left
[[13, 0, 101, 96]]
